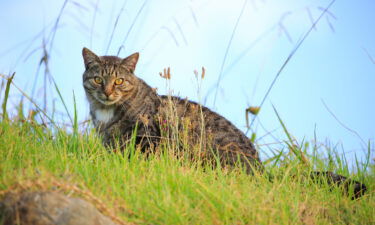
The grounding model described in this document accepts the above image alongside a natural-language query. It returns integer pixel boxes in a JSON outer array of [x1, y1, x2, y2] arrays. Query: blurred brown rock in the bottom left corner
[[0, 191, 116, 225]]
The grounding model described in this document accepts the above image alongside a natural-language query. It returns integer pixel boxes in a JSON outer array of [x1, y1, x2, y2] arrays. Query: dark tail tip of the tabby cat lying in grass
[[310, 171, 367, 199]]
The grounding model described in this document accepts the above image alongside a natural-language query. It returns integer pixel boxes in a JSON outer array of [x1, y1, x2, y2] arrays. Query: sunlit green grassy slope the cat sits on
[[0, 122, 375, 224]]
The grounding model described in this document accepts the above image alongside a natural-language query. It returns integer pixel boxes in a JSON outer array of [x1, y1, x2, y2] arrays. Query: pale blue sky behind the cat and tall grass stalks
[[0, 0, 375, 165]]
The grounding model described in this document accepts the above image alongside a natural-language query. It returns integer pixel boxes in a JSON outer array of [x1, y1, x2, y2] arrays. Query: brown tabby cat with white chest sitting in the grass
[[82, 48, 366, 197]]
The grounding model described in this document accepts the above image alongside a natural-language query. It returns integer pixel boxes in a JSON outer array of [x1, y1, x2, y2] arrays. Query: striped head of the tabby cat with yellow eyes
[[82, 48, 139, 106]]
